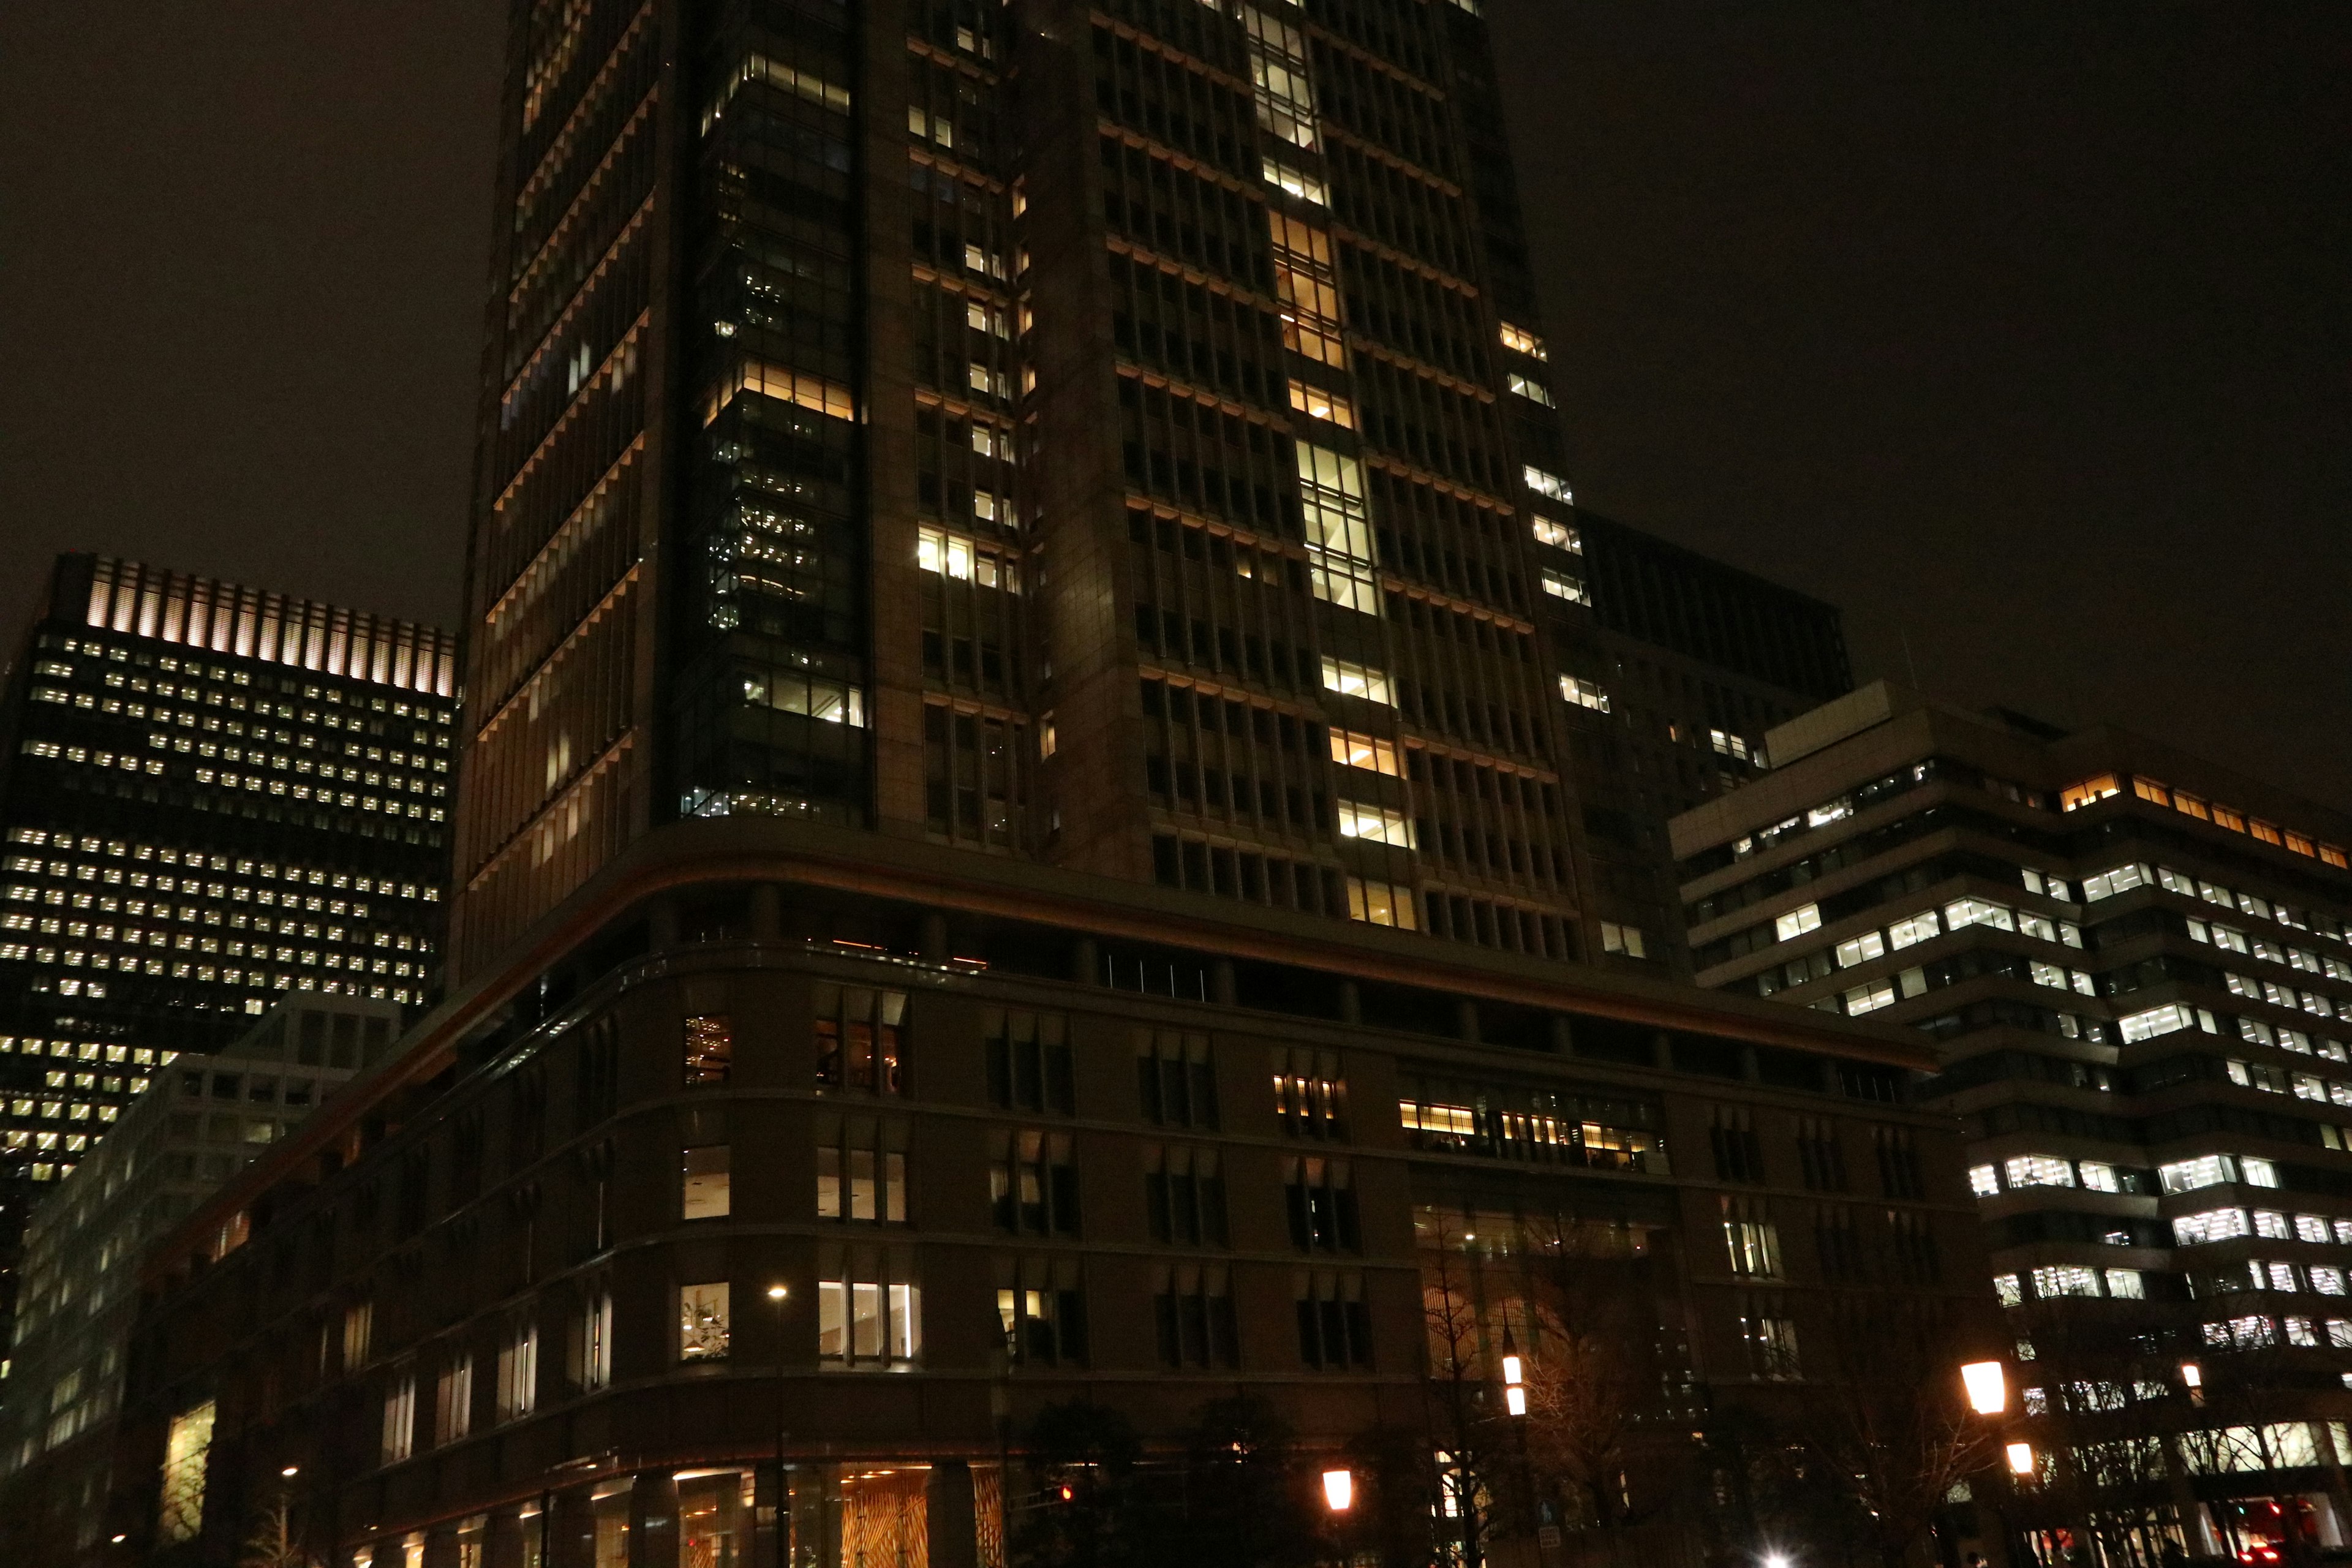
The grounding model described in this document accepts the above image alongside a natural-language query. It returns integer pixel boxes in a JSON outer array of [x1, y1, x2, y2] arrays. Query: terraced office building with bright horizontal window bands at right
[[1675, 682, 2352, 1561]]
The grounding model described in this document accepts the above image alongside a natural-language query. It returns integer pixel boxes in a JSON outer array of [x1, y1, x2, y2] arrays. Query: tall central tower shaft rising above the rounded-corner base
[[454, 0, 1618, 973]]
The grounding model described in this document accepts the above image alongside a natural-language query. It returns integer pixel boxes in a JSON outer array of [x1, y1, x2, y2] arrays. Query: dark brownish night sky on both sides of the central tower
[[0, 12, 2352, 806]]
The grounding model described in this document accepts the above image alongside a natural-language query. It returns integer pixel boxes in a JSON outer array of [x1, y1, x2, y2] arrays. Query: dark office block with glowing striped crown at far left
[[0, 555, 456, 1180]]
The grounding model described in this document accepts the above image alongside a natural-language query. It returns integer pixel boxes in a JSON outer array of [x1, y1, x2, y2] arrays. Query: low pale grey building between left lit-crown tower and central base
[[0, 992, 400, 1551]]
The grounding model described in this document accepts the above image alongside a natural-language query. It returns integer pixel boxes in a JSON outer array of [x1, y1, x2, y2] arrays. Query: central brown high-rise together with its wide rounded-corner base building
[[83, 12, 1990, 1568]]
